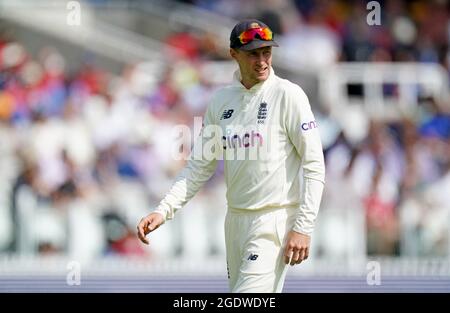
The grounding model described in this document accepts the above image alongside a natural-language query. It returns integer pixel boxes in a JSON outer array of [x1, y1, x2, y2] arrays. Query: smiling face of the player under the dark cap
[[230, 47, 272, 88]]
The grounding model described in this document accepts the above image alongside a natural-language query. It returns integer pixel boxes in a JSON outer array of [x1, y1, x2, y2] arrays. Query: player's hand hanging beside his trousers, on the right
[[284, 230, 311, 265]]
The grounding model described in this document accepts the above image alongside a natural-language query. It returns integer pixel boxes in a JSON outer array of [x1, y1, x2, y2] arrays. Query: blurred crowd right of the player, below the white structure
[[319, 103, 450, 257]]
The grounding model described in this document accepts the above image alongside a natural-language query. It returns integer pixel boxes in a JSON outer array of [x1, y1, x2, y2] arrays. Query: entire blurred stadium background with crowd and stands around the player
[[0, 0, 450, 292]]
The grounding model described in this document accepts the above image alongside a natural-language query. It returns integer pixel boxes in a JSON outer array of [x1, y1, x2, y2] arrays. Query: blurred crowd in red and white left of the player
[[0, 32, 225, 259]]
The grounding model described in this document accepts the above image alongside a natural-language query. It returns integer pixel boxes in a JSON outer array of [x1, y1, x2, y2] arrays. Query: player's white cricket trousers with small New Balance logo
[[225, 208, 296, 293]]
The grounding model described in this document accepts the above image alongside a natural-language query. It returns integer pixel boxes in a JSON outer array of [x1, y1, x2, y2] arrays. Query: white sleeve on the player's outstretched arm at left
[[154, 100, 217, 221]]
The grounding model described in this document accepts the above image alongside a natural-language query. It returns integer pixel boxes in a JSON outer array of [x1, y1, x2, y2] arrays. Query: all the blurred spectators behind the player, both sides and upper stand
[[0, 0, 450, 259]]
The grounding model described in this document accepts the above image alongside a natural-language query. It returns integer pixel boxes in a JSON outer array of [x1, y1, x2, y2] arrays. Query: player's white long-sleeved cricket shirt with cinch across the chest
[[155, 68, 325, 234]]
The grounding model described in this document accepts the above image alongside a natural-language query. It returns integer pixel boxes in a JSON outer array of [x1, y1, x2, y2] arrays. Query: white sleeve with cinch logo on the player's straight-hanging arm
[[286, 86, 325, 235]]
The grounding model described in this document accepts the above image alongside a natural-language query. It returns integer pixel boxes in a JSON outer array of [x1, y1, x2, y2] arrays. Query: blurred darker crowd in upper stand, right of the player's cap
[[180, 0, 450, 70]]
